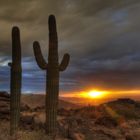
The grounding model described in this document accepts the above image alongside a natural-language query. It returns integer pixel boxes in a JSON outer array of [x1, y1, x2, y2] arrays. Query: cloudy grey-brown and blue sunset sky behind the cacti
[[0, 0, 140, 98]]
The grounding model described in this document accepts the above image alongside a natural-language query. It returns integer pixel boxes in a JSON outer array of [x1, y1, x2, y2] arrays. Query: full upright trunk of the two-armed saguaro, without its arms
[[46, 14, 59, 134]]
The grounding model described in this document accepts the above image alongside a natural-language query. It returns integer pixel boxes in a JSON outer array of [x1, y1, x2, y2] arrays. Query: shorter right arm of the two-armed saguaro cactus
[[59, 53, 70, 71]]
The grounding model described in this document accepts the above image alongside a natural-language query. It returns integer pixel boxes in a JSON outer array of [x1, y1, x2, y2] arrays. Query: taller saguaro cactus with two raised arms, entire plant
[[33, 15, 70, 135]]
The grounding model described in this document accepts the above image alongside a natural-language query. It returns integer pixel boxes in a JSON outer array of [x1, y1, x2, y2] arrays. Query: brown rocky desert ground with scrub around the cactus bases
[[0, 92, 140, 140]]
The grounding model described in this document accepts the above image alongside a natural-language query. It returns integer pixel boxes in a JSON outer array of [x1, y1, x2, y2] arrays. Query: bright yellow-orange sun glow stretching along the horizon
[[60, 88, 140, 105]]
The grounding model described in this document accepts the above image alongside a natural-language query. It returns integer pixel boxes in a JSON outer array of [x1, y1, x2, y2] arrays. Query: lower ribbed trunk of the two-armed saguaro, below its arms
[[46, 70, 59, 134]]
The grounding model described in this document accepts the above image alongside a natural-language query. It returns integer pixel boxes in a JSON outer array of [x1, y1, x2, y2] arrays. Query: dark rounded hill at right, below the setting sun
[[99, 98, 140, 119]]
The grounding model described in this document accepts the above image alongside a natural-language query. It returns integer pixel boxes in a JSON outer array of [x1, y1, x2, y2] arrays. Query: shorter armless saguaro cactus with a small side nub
[[8, 27, 22, 135]]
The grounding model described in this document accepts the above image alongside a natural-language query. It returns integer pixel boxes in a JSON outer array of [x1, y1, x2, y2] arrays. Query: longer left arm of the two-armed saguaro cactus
[[33, 41, 47, 70]]
